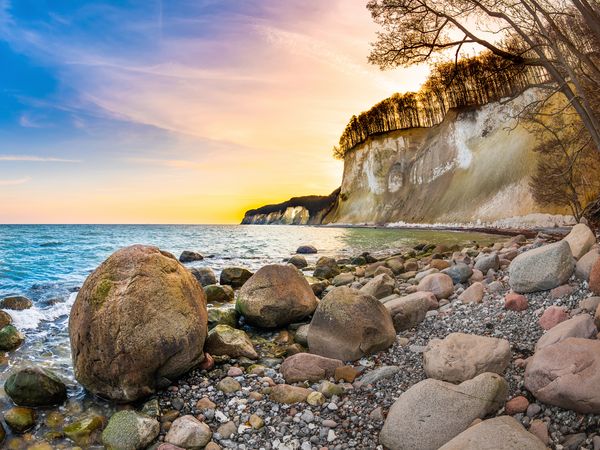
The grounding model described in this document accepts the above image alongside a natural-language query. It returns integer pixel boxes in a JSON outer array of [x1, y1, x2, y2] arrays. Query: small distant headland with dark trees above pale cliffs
[[242, 188, 340, 225]]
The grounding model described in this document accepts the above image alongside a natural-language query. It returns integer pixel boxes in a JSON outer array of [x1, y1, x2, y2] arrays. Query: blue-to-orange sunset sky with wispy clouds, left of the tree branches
[[0, 0, 427, 223]]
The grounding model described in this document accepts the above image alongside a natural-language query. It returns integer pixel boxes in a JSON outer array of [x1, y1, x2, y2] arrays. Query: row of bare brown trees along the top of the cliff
[[334, 52, 547, 159]]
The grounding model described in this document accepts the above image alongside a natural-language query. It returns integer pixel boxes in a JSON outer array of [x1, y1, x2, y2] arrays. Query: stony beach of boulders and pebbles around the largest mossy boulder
[[0, 226, 600, 450]]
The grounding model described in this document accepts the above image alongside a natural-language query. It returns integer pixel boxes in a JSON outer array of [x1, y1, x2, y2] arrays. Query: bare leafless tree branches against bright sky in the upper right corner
[[367, 0, 600, 150]]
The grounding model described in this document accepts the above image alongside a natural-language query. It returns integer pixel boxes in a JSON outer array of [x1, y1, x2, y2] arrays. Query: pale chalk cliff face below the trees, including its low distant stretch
[[243, 89, 570, 227]]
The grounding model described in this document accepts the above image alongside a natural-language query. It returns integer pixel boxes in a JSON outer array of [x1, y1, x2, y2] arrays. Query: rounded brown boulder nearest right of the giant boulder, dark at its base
[[236, 264, 317, 328]]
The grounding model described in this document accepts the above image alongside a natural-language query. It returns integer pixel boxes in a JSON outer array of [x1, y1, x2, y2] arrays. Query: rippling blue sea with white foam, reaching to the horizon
[[0, 225, 501, 407]]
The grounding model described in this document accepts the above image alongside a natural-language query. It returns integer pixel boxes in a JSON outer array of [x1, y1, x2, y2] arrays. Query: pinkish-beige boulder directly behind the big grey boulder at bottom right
[[423, 333, 511, 383]]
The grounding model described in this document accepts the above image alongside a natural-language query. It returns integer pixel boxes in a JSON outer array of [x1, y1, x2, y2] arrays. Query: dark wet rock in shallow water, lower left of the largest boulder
[[4, 367, 67, 407]]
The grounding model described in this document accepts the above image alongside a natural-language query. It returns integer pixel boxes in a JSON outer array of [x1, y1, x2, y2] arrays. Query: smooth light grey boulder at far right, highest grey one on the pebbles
[[509, 241, 575, 294]]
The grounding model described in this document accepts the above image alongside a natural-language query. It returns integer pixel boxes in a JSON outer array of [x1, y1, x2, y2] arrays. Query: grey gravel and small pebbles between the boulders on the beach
[[158, 239, 600, 450]]
